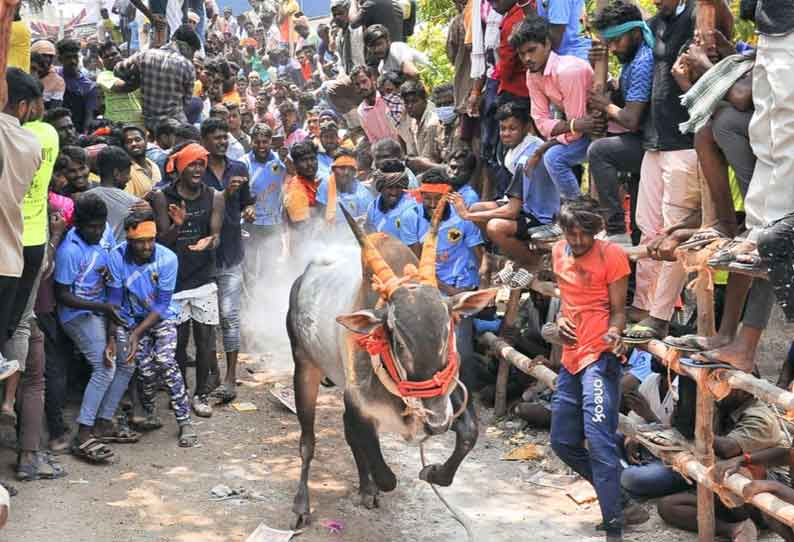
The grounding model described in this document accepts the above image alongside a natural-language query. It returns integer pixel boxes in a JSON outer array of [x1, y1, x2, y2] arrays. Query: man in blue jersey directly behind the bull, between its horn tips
[[367, 160, 419, 239]]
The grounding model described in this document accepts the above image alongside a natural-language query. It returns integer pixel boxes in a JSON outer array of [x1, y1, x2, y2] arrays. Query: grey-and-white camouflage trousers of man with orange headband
[[135, 320, 190, 425]]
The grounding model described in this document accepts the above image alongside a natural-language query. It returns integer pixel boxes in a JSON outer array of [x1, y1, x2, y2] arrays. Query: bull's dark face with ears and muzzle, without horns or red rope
[[337, 284, 495, 435]]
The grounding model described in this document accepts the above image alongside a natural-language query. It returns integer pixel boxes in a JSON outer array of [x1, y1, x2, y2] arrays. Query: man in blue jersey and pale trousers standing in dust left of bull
[[241, 123, 287, 277]]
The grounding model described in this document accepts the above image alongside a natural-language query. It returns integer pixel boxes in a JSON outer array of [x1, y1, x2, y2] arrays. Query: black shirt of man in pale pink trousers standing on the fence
[[643, 0, 695, 151]]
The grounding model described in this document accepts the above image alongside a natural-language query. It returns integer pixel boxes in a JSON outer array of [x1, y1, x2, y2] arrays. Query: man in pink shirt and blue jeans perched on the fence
[[509, 14, 606, 199]]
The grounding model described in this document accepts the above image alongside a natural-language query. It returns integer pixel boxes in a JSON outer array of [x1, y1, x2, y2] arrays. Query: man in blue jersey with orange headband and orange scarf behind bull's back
[[317, 149, 375, 226]]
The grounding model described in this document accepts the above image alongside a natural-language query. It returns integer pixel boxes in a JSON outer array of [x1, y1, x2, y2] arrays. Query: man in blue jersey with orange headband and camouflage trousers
[[108, 210, 198, 448]]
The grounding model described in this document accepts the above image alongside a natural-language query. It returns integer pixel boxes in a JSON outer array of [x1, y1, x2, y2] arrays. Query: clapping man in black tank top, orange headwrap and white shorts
[[152, 143, 224, 417]]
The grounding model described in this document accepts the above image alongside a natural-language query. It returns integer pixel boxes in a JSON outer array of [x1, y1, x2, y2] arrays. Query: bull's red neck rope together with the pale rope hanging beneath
[[356, 325, 460, 416]]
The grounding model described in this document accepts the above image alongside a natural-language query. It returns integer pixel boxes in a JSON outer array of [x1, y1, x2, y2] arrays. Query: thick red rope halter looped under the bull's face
[[356, 326, 459, 399]]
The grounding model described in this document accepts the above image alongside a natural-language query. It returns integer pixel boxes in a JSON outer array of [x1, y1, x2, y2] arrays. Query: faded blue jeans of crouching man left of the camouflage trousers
[[63, 313, 135, 427]]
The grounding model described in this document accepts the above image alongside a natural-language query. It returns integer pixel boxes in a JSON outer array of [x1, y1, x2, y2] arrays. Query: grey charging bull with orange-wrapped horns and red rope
[[287, 204, 495, 528]]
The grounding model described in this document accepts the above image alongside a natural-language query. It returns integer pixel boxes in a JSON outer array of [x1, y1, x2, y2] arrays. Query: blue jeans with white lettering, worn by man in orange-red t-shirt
[[551, 352, 623, 534]]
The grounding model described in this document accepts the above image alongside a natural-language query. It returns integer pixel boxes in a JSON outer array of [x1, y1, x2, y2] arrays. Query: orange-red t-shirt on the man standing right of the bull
[[552, 239, 631, 374]]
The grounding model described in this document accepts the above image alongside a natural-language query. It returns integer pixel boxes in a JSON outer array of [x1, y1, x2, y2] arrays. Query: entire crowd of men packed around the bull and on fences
[[0, 0, 794, 541]]
